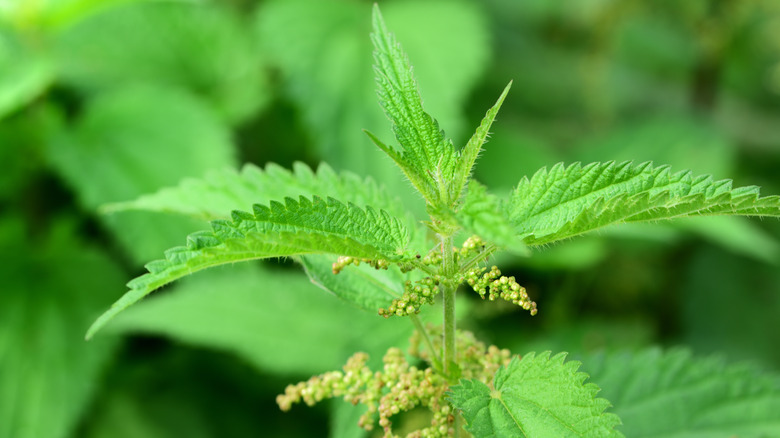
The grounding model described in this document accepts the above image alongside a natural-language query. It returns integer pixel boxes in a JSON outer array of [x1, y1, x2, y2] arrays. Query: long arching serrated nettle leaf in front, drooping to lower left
[[87, 197, 409, 338]]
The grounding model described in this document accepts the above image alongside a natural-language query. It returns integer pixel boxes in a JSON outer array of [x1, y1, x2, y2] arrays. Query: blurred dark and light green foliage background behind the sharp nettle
[[0, 0, 780, 438]]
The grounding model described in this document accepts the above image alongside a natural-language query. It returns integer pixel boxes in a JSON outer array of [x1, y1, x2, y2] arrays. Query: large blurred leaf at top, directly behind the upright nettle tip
[[257, 0, 489, 193]]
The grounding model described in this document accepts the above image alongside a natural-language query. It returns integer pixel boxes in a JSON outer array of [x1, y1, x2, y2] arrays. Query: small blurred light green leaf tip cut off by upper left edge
[[0, 30, 54, 119]]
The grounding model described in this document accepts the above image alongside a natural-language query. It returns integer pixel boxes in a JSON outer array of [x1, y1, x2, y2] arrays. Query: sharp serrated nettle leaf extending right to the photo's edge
[[507, 161, 780, 245]]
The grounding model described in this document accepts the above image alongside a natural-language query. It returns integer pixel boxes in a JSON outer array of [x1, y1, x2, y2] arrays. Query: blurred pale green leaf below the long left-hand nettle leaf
[[106, 264, 426, 375]]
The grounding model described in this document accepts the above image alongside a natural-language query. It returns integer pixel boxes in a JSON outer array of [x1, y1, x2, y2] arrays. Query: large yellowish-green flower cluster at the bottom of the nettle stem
[[276, 328, 511, 438]]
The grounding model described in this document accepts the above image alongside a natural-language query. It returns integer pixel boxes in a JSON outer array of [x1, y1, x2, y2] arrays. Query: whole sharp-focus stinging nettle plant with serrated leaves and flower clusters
[[87, 6, 780, 437]]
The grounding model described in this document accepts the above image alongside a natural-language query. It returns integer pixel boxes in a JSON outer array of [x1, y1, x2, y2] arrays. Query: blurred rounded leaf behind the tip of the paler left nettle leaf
[[46, 87, 235, 264]]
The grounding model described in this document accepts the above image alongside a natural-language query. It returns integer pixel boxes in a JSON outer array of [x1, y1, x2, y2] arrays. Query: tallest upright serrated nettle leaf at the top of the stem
[[370, 5, 457, 205]]
